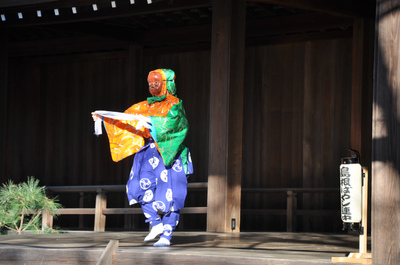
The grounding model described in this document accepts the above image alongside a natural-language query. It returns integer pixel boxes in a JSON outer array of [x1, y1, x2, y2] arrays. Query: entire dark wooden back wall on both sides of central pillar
[[0, 35, 352, 231]]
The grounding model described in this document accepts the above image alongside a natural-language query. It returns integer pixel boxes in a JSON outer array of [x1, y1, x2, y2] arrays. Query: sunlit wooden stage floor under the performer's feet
[[0, 231, 368, 265]]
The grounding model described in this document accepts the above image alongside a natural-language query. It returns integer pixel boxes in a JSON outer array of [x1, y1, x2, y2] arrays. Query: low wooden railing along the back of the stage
[[43, 182, 339, 232]]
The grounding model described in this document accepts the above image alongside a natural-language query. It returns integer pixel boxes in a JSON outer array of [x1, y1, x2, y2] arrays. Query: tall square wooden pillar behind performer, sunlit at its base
[[207, 0, 245, 232]]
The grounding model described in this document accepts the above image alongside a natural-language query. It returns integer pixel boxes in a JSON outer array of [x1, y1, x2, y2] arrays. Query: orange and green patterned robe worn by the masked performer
[[97, 69, 189, 173]]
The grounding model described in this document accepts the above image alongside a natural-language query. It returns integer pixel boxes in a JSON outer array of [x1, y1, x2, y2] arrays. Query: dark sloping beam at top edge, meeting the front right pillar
[[248, 0, 375, 18]]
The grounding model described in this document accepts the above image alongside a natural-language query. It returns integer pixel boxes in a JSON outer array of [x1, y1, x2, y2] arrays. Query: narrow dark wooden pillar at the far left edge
[[0, 29, 8, 180]]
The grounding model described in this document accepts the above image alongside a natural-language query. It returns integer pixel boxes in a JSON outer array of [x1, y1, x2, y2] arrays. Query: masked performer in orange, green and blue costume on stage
[[92, 69, 193, 246]]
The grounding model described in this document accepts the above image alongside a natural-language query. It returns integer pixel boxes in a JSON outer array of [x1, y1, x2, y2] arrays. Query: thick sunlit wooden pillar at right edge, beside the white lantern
[[371, 0, 400, 265]]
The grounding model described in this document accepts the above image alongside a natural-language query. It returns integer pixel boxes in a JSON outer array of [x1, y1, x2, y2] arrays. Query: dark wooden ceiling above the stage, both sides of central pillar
[[0, 0, 375, 55]]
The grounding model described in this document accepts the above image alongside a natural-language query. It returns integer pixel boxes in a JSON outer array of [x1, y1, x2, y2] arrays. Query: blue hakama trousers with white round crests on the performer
[[126, 139, 193, 240]]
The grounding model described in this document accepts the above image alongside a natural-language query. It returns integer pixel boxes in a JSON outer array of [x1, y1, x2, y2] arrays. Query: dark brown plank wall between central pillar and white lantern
[[242, 39, 352, 231]]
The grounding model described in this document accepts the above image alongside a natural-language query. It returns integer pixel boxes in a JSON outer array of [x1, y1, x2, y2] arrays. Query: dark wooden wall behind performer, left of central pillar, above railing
[[3, 52, 209, 185]]
